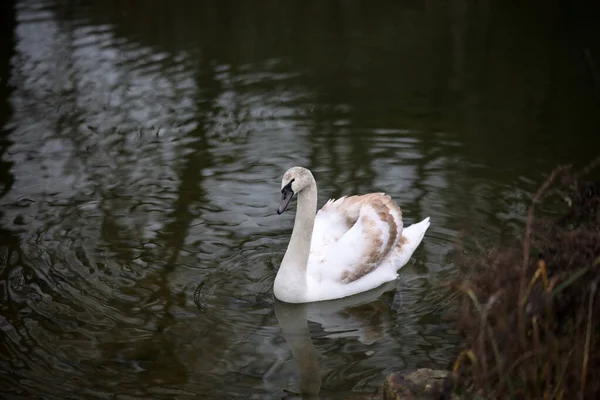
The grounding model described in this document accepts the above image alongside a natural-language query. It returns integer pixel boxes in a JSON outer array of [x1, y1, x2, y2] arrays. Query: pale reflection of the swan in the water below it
[[274, 282, 396, 399]]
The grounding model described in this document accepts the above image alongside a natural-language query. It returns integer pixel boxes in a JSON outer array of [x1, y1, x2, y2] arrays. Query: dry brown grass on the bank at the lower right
[[440, 159, 600, 399]]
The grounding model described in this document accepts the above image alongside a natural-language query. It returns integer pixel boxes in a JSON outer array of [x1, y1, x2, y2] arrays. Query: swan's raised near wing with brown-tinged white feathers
[[322, 193, 402, 283]]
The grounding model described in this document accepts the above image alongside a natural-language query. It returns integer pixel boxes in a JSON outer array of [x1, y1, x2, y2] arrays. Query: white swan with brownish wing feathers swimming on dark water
[[273, 167, 429, 303]]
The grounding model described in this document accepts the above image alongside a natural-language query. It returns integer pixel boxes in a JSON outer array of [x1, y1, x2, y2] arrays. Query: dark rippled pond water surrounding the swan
[[0, 0, 600, 399]]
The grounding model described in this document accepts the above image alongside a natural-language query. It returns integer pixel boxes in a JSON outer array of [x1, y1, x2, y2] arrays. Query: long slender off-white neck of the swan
[[274, 181, 317, 302]]
